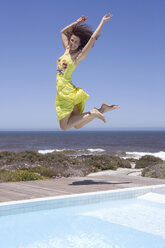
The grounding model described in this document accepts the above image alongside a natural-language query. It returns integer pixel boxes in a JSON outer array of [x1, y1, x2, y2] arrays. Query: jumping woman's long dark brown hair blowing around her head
[[67, 24, 99, 50]]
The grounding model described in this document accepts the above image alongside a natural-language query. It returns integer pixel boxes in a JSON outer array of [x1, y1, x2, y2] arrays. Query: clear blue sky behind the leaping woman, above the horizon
[[0, 0, 165, 130]]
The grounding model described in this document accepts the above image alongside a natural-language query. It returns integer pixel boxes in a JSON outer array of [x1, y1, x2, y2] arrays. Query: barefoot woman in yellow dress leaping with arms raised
[[55, 14, 120, 130]]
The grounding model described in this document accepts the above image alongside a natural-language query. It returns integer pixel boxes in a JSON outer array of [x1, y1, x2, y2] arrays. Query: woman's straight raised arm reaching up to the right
[[77, 13, 112, 63]]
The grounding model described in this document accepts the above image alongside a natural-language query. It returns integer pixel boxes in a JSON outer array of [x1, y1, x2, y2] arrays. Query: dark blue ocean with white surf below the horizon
[[0, 131, 165, 160]]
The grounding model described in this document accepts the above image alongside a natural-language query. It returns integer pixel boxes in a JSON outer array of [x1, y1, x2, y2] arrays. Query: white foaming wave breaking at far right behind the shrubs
[[123, 151, 165, 160]]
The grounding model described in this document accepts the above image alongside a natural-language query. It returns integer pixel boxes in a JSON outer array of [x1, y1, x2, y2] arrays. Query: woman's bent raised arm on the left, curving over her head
[[61, 16, 88, 50]]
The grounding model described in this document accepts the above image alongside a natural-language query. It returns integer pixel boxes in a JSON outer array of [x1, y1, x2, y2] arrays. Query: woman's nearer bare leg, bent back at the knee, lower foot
[[60, 105, 105, 130]]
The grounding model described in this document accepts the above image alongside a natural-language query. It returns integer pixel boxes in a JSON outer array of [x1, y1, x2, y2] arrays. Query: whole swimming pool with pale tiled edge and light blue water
[[0, 185, 165, 248]]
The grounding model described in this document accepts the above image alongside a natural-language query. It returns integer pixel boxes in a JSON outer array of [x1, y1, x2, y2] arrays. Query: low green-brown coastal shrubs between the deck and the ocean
[[0, 151, 165, 182]]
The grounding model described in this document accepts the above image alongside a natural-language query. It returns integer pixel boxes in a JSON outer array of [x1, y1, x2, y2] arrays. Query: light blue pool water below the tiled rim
[[0, 198, 165, 248]]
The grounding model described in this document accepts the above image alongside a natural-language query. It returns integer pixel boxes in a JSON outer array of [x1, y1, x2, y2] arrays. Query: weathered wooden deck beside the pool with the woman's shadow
[[0, 173, 165, 202]]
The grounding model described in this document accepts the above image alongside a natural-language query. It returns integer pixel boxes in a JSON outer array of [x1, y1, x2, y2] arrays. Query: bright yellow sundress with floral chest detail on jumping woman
[[55, 53, 89, 121]]
